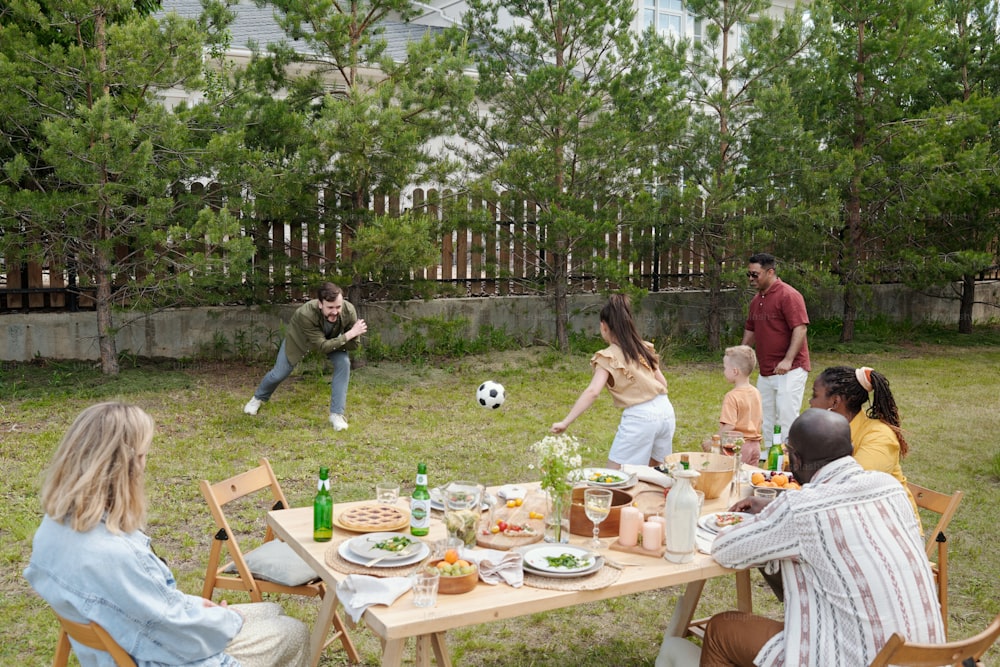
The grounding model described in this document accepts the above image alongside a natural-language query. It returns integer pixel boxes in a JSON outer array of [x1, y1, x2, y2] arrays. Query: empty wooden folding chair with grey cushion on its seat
[[201, 458, 360, 662]]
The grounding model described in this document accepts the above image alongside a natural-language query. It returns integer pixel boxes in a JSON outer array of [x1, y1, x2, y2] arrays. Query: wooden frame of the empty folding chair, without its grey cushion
[[200, 458, 360, 663]]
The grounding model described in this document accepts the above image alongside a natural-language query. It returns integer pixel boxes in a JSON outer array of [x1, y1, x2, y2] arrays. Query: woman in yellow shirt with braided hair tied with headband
[[809, 366, 919, 519]]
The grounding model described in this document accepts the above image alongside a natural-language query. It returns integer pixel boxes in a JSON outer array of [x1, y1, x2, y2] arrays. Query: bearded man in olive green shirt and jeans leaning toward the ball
[[243, 283, 368, 431]]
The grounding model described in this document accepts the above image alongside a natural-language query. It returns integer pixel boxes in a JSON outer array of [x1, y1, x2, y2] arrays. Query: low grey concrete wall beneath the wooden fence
[[0, 281, 1000, 361]]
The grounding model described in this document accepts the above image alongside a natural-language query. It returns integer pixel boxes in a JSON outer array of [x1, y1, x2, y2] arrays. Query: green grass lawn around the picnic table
[[0, 344, 1000, 667]]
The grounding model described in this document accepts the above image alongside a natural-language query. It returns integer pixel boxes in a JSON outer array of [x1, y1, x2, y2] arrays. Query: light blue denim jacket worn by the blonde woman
[[24, 516, 243, 667]]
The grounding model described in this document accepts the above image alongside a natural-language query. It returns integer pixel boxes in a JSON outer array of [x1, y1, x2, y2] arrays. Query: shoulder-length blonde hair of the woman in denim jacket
[[42, 402, 154, 533]]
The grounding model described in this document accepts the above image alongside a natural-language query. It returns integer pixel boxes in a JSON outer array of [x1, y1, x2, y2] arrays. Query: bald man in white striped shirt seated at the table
[[701, 408, 945, 667]]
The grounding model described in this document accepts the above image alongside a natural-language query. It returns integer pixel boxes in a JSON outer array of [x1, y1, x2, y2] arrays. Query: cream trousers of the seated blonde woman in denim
[[226, 602, 310, 667]]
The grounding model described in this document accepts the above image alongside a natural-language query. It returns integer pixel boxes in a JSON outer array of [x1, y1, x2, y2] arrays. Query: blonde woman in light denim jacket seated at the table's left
[[24, 403, 309, 667]]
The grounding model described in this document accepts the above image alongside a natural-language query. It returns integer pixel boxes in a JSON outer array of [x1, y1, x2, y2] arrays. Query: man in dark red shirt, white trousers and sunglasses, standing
[[743, 252, 810, 453]]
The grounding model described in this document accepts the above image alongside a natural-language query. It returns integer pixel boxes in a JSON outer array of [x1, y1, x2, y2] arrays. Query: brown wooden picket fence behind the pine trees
[[0, 188, 1000, 312]]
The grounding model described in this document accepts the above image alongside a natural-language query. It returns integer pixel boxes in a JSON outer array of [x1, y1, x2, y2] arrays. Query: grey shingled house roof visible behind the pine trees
[[162, 0, 442, 60]]
